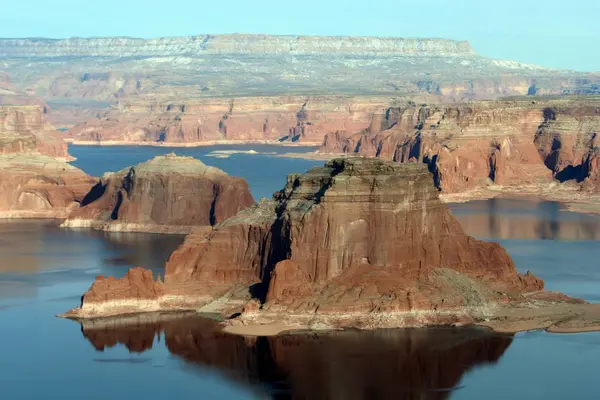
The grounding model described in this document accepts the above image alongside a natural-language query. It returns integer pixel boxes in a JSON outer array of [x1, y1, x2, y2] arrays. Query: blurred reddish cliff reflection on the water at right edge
[[450, 199, 600, 240]]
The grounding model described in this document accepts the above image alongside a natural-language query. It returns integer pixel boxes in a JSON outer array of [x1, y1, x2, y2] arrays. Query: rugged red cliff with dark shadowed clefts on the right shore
[[320, 97, 600, 193]]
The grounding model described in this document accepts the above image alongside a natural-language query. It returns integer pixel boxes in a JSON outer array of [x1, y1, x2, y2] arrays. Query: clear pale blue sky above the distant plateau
[[0, 0, 600, 71]]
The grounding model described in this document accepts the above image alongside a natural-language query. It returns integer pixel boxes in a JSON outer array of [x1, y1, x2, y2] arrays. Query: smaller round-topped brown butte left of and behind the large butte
[[62, 154, 254, 234]]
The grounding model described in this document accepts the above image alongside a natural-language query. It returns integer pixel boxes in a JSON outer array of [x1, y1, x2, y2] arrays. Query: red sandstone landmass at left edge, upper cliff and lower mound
[[0, 106, 94, 218]]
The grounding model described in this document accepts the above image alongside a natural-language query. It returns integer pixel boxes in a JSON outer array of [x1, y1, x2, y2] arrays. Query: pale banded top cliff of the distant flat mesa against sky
[[0, 34, 475, 58]]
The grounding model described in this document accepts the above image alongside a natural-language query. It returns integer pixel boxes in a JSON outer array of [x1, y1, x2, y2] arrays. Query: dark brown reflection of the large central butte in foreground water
[[82, 314, 512, 400]]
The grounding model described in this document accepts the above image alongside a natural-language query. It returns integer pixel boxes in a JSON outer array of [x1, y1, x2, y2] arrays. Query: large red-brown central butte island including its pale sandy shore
[[63, 158, 600, 334]]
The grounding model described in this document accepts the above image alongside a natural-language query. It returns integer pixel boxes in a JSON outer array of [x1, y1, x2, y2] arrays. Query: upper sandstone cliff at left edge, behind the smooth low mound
[[0, 105, 72, 160]]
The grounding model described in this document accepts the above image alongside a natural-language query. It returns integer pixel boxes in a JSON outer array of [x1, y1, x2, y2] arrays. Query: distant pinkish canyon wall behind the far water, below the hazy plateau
[[67, 96, 393, 145]]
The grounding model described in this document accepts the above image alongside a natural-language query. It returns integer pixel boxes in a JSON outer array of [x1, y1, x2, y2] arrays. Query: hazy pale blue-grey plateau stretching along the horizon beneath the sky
[[0, 35, 600, 130]]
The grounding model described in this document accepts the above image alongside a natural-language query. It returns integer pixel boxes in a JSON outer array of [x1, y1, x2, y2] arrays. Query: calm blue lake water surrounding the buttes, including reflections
[[0, 146, 600, 399]]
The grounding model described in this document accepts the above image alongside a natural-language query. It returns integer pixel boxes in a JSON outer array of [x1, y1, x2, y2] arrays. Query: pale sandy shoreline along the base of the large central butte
[[56, 302, 600, 337]]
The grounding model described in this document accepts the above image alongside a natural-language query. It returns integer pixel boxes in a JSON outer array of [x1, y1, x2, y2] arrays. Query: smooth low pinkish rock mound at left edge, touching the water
[[0, 153, 95, 218]]
